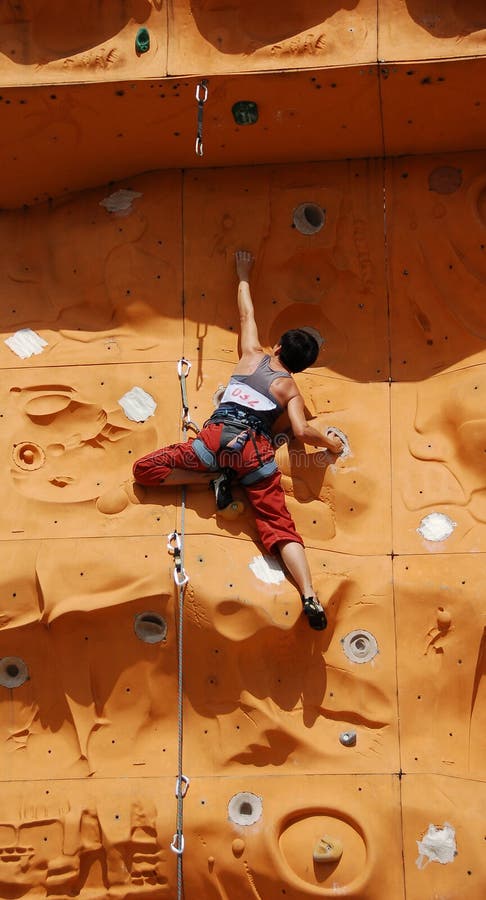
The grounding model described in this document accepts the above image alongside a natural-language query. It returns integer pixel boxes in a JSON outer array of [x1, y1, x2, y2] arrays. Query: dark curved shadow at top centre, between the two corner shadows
[[191, 0, 359, 53]]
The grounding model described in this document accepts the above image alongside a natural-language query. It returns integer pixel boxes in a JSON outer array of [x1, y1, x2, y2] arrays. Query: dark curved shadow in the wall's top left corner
[[0, 0, 153, 65]]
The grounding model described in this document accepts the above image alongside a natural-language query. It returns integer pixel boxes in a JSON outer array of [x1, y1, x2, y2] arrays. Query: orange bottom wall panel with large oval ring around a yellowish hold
[[182, 774, 404, 900]]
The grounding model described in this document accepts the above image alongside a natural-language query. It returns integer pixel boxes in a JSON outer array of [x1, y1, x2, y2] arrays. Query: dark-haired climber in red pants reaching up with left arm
[[133, 250, 344, 631]]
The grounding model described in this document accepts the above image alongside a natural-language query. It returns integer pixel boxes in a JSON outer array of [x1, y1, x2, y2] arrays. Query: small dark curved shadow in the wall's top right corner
[[407, 0, 486, 38]]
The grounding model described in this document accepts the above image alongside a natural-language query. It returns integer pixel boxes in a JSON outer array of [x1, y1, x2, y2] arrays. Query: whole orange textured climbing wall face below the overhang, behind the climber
[[0, 153, 486, 900]]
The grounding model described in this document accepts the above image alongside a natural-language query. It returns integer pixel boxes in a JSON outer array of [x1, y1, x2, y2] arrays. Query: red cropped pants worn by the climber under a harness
[[133, 424, 303, 553]]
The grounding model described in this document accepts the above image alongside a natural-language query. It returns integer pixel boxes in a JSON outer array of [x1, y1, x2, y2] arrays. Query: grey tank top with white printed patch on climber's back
[[218, 353, 292, 430]]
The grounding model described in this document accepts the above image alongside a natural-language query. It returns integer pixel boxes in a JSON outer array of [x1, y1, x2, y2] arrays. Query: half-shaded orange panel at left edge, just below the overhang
[[0, 173, 182, 368]]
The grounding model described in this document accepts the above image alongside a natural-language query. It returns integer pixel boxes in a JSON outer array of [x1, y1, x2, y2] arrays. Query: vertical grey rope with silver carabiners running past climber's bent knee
[[167, 357, 199, 900]]
